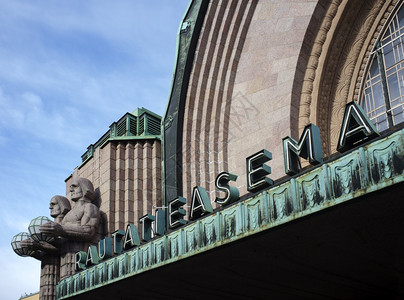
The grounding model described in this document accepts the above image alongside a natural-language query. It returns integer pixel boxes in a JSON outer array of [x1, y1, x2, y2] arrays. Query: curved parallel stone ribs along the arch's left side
[[183, 0, 257, 206]]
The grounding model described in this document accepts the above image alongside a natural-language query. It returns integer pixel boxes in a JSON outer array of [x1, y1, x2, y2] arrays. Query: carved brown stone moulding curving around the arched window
[[291, 0, 398, 155]]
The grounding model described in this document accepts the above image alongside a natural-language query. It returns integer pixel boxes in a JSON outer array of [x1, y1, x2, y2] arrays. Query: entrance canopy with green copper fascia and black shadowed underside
[[57, 130, 404, 299]]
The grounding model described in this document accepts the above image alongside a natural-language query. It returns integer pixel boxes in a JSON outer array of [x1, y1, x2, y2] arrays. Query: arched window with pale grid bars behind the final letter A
[[360, 2, 404, 131]]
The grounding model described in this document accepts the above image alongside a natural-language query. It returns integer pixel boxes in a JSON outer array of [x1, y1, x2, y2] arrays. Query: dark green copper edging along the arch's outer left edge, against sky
[[162, 0, 209, 203]]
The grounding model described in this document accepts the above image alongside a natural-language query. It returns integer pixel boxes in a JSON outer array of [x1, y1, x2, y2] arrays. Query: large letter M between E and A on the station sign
[[282, 124, 323, 175]]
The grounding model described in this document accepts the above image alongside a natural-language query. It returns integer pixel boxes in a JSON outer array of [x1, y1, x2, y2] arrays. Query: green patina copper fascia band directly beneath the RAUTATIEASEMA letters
[[57, 129, 404, 299]]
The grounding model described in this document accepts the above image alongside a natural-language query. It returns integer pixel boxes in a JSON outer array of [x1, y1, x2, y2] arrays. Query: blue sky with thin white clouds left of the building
[[0, 0, 189, 300]]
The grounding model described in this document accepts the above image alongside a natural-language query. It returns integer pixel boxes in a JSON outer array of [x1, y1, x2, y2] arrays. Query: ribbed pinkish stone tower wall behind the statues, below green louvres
[[66, 139, 162, 237]]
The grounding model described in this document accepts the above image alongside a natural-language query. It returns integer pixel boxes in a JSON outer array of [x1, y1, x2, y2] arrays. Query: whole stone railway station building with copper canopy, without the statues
[[11, 0, 404, 299]]
